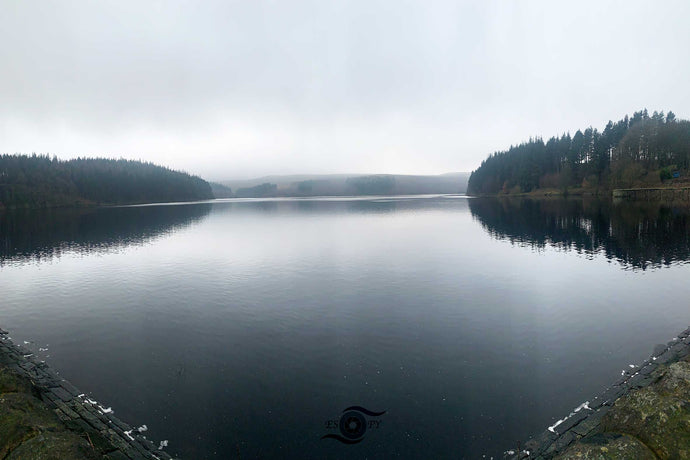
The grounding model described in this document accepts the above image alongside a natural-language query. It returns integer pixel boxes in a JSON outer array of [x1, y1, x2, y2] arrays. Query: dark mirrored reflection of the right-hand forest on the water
[[469, 198, 690, 270]]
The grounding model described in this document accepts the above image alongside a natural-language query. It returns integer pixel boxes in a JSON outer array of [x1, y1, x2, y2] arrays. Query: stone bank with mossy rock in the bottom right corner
[[504, 328, 690, 460]]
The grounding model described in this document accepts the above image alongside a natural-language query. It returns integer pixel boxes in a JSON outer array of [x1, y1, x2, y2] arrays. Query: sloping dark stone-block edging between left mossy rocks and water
[[0, 329, 171, 460]]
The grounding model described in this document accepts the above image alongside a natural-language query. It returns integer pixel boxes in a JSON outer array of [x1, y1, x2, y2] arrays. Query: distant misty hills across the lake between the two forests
[[221, 172, 470, 197]]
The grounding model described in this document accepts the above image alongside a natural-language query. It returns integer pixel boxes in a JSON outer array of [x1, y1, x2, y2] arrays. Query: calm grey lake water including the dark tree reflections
[[0, 196, 690, 459]]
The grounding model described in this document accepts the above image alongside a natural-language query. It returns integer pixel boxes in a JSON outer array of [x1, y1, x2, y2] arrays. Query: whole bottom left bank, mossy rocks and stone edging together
[[0, 329, 172, 460]]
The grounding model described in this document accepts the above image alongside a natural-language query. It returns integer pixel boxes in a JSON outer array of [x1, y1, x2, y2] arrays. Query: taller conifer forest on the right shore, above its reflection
[[468, 109, 690, 195]]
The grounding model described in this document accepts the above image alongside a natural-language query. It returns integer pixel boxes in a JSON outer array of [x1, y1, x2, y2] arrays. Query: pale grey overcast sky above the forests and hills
[[0, 0, 690, 180]]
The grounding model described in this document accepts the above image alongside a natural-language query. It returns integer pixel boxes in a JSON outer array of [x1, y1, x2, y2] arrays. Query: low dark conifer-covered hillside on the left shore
[[0, 154, 213, 208]]
